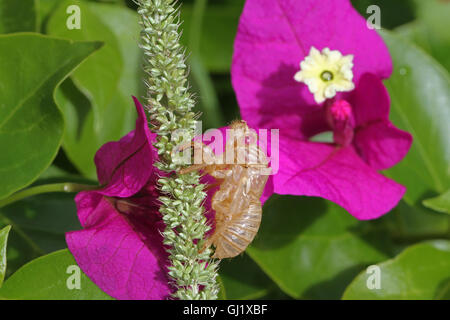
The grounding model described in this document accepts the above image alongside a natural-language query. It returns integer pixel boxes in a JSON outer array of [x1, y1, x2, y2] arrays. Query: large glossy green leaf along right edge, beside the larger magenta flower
[[376, 32, 450, 240]]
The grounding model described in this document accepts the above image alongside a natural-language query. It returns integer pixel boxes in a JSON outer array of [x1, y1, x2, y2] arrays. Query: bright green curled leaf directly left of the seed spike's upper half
[[47, 1, 142, 178]]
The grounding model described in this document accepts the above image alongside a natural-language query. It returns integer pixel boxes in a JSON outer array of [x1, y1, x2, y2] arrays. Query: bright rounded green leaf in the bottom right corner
[[343, 240, 450, 300]]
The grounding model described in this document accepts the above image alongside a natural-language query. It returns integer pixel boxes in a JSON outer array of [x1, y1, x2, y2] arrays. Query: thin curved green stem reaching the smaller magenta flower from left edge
[[0, 182, 98, 208]]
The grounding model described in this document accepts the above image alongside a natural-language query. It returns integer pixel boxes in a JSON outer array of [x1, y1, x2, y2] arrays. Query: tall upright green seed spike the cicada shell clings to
[[138, 0, 219, 300]]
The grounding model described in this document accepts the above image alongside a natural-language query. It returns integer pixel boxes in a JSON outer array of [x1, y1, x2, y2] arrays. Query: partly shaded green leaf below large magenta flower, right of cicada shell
[[247, 195, 394, 299]]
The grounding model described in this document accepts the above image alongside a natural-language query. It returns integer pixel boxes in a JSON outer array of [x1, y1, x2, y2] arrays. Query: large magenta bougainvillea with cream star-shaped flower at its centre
[[232, 0, 412, 220]]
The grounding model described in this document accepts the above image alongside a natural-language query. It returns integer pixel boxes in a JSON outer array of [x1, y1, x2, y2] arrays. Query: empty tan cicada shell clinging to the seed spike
[[180, 121, 271, 259]]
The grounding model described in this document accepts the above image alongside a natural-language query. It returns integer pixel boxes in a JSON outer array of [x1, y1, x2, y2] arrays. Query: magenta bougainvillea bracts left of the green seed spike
[[66, 98, 170, 299]]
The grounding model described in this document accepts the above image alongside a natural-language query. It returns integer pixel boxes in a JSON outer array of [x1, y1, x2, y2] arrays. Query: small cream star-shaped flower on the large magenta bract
[[294, 47, 355, 103]]
